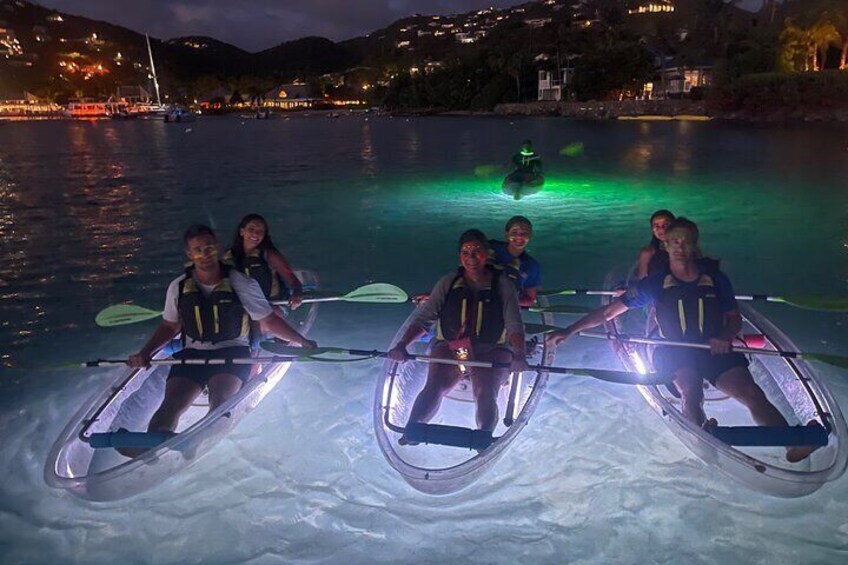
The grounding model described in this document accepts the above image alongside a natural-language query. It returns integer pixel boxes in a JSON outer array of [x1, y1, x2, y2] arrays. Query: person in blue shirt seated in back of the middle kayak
[[489, 216, 542, 308]]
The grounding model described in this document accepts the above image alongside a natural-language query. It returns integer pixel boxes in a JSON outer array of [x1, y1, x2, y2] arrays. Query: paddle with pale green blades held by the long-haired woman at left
[[94, 283, 409, 327]]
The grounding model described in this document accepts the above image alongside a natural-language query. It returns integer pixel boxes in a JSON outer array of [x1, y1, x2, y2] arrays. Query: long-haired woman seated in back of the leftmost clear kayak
[[224, 214, 303, 310]]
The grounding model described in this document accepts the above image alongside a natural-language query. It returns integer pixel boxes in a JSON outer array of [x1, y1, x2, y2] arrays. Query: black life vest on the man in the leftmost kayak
[[177, 263, 250, 343]]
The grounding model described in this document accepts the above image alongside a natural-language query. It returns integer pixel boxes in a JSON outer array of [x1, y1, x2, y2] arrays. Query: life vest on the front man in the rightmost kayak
[[656, 259, 724, 343]]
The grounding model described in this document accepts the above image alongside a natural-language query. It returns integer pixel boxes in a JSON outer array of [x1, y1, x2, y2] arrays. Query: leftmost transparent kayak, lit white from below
[[44, 271, 318, 501]]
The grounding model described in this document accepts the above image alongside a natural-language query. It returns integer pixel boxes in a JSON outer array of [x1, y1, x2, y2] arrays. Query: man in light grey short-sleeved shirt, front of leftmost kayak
[[126, 225, 317, 457]]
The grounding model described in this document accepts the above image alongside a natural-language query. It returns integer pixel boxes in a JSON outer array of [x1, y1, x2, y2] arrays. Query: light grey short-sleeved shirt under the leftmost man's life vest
[[162, 269, 273, 350]]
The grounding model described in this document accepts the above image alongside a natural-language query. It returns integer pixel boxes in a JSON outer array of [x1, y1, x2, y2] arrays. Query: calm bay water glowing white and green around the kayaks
[[0, 115, 848, 563]]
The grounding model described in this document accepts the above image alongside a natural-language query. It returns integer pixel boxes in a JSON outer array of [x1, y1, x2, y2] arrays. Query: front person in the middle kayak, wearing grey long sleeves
[[388, 230, 527, 444]]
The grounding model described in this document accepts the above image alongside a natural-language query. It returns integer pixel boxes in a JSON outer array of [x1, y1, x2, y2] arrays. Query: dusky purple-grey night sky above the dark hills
[[36, 0, 761, 51]]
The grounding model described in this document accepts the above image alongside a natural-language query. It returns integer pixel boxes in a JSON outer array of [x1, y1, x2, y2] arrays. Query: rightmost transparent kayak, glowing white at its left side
[[606, 266, 848, 498]]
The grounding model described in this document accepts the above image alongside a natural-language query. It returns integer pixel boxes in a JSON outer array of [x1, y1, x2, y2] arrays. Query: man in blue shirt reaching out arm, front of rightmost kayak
[[545, 217, 815, 462]]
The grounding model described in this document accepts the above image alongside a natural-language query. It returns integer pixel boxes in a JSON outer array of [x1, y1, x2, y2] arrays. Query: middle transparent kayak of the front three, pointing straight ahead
[[373, 297, 555, 494]]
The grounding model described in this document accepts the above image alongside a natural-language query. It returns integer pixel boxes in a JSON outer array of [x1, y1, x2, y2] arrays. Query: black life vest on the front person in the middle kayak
[[436, 267, 506, 344]]
